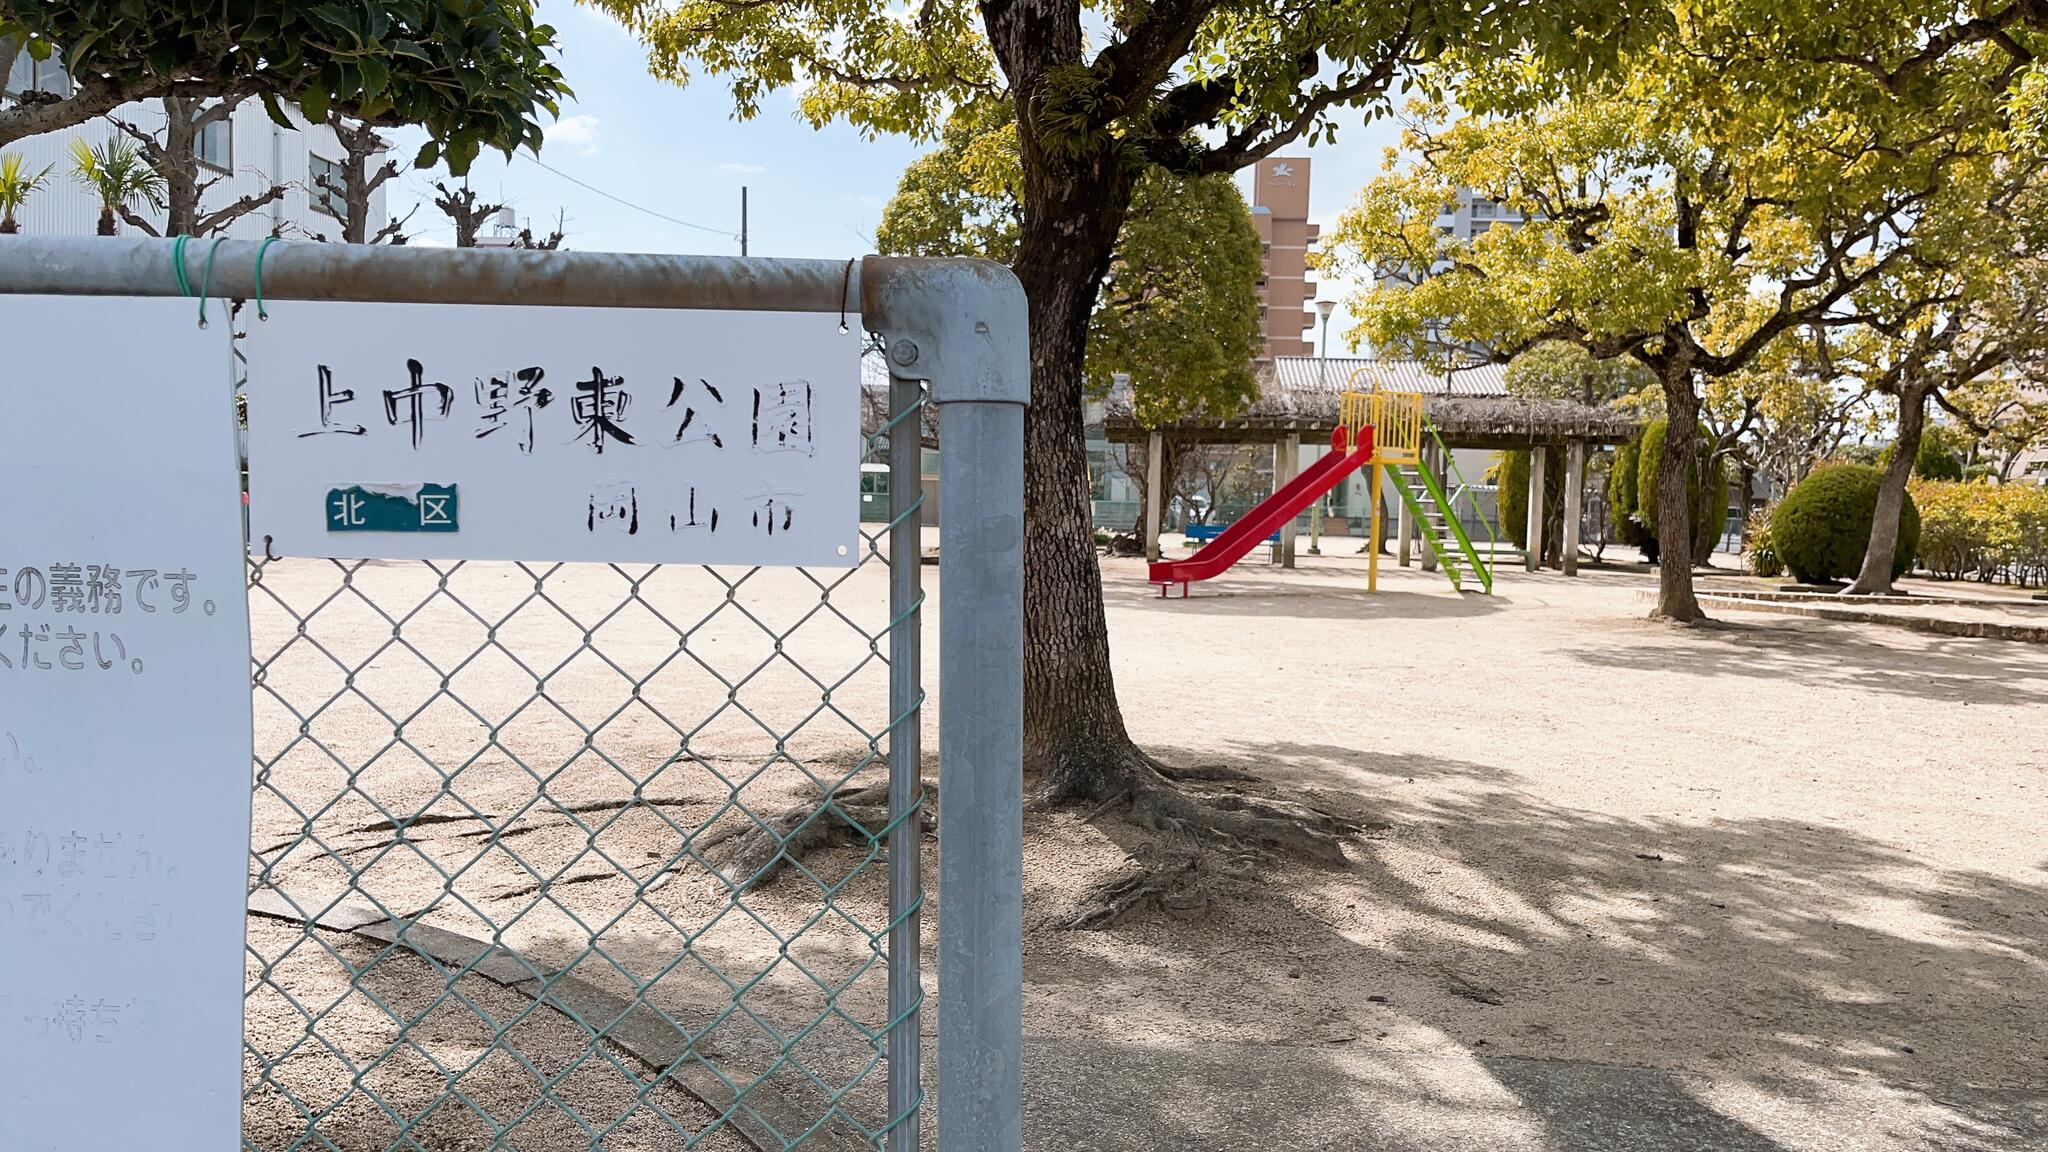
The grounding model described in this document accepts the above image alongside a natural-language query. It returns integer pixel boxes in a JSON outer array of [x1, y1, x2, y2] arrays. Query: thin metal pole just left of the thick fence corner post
[[889, 379, 924, 1152]]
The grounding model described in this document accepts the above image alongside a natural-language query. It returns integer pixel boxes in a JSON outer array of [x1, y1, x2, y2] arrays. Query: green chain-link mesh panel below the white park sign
[[244, 379, 928, 1152]]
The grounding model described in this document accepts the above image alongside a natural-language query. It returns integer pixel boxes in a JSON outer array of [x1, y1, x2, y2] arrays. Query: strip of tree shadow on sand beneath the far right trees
[[1567, 617, 2048, 705]]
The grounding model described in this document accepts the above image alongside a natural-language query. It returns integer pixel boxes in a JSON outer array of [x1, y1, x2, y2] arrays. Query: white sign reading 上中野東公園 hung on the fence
[[244, 301, 860, 566]]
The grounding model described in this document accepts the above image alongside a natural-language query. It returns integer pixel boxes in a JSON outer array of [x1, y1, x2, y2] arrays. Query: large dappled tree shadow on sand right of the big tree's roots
[[1028, 744, 2048, 1152]]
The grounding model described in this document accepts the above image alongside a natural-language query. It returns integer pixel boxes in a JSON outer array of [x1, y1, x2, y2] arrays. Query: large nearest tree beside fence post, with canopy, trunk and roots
[[592, 0, 1624, 857]]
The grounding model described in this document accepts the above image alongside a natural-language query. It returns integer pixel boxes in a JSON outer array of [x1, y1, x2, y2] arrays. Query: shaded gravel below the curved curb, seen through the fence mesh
[[235, 920, 752, 1152]]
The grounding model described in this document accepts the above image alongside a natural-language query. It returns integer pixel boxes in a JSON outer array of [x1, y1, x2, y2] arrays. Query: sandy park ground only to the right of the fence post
[[1028, 556, 2048, 1148]]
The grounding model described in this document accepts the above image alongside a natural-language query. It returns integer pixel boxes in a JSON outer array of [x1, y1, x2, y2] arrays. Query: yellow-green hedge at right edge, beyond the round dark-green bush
[[1913, 480, 2048, 584]]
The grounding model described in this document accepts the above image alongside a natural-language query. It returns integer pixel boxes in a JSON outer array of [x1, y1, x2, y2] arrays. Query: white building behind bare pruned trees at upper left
[[0, 51, 387, 240]]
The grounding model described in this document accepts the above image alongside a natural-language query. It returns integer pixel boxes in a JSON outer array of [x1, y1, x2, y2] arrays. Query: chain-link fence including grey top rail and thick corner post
[[0, 238, 1028, 1152]]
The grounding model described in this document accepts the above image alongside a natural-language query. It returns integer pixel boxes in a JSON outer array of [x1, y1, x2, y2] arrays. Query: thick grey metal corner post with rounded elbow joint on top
[[862, 258, 1030, 1152]]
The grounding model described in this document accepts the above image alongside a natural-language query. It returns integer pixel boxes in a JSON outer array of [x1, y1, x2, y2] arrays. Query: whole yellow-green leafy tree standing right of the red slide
[[1323, 24, 1995, 621]]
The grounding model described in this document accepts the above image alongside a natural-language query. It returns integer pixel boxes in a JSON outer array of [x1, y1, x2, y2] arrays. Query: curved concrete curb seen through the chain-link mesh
[[248, 888, 874, 1152]]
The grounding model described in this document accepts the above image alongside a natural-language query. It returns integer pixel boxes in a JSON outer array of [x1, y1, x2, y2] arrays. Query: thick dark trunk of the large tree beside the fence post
[[1016, 156, 1145, 801]]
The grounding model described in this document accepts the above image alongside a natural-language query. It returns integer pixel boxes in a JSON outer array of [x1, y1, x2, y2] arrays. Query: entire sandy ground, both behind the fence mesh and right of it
[[250, 549, 2048, 1152]]
